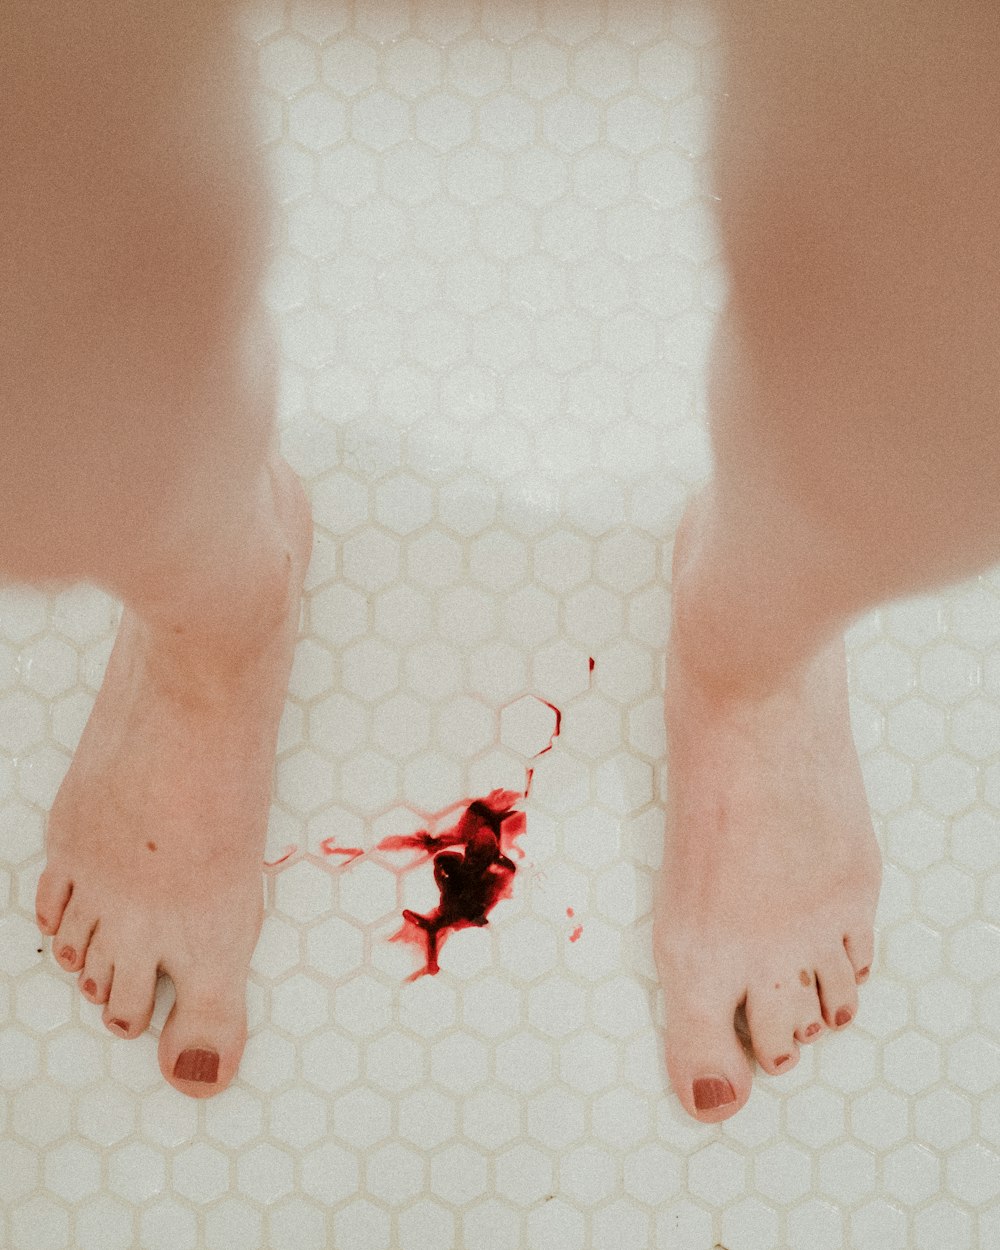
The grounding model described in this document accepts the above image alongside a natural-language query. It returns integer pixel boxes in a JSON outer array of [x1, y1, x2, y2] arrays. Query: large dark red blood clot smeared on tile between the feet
[[379, 790, 526, 981]]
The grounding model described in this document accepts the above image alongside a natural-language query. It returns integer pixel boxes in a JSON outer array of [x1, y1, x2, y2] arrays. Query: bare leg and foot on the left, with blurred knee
[[0, 0, 311, 1096]]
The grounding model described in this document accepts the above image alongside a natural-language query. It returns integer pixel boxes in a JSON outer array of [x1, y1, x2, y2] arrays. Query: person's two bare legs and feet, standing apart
[[0, 0, 1000, 1123]]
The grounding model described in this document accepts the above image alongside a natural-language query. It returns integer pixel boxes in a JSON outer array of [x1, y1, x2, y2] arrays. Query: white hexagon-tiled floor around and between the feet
[[0, 0, 1000, 1250]]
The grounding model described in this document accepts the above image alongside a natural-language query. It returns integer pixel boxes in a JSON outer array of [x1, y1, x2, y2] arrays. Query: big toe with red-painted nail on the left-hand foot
[[160, 978, 246, 1098]]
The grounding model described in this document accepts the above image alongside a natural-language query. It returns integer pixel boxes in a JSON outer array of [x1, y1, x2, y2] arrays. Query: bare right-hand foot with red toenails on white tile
[[654, 495, 881, 1123]]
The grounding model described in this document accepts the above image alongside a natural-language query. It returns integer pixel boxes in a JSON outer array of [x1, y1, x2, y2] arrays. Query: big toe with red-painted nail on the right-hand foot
[[666, 994, 753, 1124]]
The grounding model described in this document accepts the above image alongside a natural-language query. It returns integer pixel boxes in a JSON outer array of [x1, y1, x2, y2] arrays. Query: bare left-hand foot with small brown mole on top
[[35, 458, 313, 1098]]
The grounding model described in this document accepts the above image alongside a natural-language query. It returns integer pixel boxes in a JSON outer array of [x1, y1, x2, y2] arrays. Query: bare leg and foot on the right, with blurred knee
[[655, 0, 1000, 1121]]
